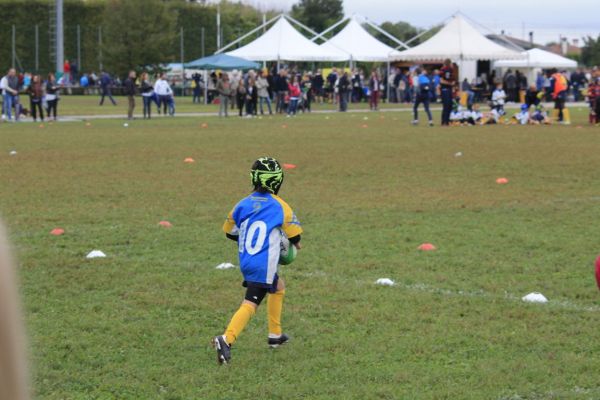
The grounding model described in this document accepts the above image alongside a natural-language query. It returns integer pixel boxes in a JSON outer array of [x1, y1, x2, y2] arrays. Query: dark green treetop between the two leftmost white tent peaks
[[292, 0, 344, 32]]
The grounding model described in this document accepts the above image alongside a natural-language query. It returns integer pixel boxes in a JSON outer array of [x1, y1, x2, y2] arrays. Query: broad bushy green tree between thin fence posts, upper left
[[102, 0, 178, 76]]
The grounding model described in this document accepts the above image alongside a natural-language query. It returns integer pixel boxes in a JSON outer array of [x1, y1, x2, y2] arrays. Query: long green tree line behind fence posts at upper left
[[0, 0, 277, 75]]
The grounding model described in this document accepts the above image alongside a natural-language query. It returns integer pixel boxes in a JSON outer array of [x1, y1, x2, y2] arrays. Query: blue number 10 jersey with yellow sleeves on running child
[[223, 192, 302, 287]]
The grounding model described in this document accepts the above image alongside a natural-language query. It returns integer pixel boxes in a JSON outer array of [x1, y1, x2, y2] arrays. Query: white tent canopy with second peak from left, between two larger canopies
[[321, 18, 400, 62]]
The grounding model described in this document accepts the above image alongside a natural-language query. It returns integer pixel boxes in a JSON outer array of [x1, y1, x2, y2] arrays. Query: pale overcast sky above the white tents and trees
[[244, 0, 600, 44]]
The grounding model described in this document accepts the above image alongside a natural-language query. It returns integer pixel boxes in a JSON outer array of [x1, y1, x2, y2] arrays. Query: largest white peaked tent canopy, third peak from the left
[[392, 14, 524, 61]]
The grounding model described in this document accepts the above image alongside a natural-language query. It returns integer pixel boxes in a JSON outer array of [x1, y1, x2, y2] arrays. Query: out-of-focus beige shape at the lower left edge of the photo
[[0, 223, 29, 400]]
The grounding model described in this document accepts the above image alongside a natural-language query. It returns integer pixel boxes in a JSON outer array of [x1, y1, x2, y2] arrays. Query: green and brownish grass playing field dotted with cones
[[0, 104, 600, 399]]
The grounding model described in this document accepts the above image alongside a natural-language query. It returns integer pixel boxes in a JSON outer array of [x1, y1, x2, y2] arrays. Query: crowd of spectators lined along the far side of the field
[[0, 60, 600, 125]]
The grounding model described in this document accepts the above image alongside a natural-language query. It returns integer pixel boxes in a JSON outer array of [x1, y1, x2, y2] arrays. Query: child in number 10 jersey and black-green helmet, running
[[213, 157, 302, 364]]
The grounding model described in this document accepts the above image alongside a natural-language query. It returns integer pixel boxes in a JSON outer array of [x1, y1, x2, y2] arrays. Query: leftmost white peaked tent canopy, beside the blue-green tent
[[226, 16, 350, 61]]
